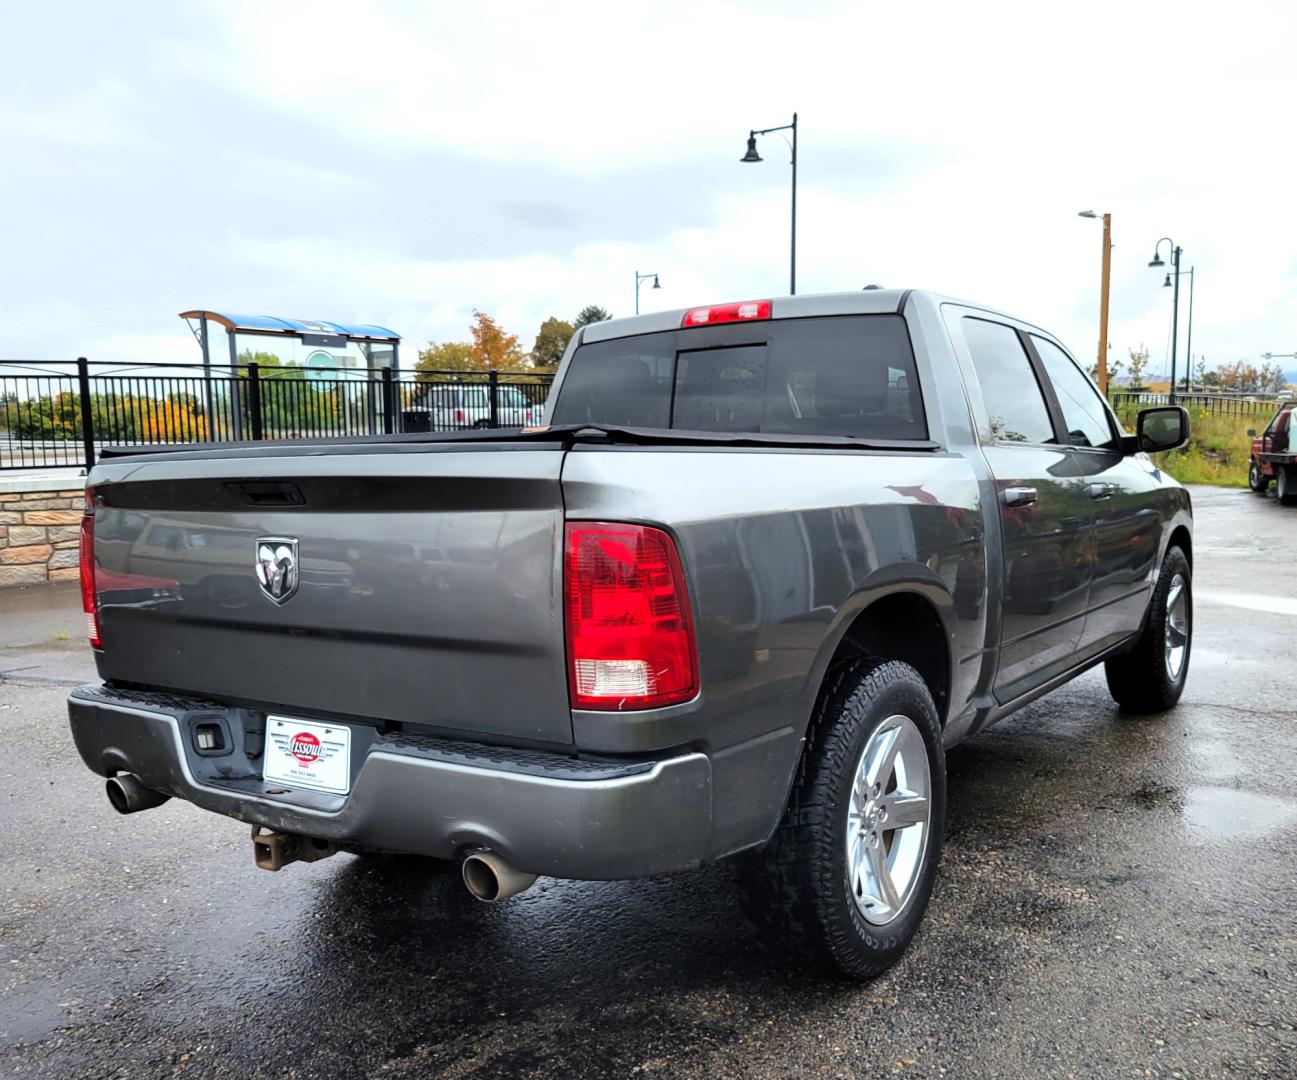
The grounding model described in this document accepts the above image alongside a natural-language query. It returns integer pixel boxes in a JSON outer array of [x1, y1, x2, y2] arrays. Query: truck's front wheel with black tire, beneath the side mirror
[[1104, 547, 1193, 713]]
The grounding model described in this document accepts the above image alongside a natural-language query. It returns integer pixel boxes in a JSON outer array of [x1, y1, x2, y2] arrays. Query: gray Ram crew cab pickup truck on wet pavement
[[69, 290, 1192, 978]]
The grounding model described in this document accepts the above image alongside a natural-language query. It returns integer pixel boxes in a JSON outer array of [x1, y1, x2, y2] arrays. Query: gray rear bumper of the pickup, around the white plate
[[67, 686, 712, 880]]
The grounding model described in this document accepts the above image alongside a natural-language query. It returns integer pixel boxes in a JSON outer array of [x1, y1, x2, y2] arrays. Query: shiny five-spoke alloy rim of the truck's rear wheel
[[846, 713, 933, 926]]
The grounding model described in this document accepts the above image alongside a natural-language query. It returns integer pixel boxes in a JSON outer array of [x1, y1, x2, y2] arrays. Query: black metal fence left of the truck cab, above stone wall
[[0, 359, 554, 469]]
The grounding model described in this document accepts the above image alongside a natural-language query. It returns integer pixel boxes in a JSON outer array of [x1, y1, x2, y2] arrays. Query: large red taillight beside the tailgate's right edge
[[565, 521, 698, 709]]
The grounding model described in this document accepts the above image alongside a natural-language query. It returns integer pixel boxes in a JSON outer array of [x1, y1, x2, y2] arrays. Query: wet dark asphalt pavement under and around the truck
[[0, 489, 1297, 1077]]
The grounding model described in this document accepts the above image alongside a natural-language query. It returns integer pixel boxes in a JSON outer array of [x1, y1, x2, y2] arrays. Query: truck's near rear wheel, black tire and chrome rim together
[[743, 660, 946, 979]]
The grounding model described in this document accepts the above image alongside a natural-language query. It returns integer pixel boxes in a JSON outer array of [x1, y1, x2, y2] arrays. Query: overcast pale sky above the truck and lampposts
[[0, 0, 1297, 370]]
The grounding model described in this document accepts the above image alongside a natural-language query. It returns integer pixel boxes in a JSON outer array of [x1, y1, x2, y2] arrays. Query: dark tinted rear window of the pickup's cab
[[549, 315, 927, 440]]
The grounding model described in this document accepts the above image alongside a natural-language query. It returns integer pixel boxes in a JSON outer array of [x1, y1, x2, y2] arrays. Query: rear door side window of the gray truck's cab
[[961, 316, 1054, 442]]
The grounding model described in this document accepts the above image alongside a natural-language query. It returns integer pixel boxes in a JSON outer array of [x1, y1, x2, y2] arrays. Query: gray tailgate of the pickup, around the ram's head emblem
[[91, 442, 572, 743]]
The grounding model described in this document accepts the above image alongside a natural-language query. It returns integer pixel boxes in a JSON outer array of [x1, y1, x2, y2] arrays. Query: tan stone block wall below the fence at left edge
[[0, 487, 86, 589]]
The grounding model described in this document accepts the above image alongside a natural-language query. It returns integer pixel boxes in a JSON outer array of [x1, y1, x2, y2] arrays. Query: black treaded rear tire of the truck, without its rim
[[739, 660, 946, 979]]
